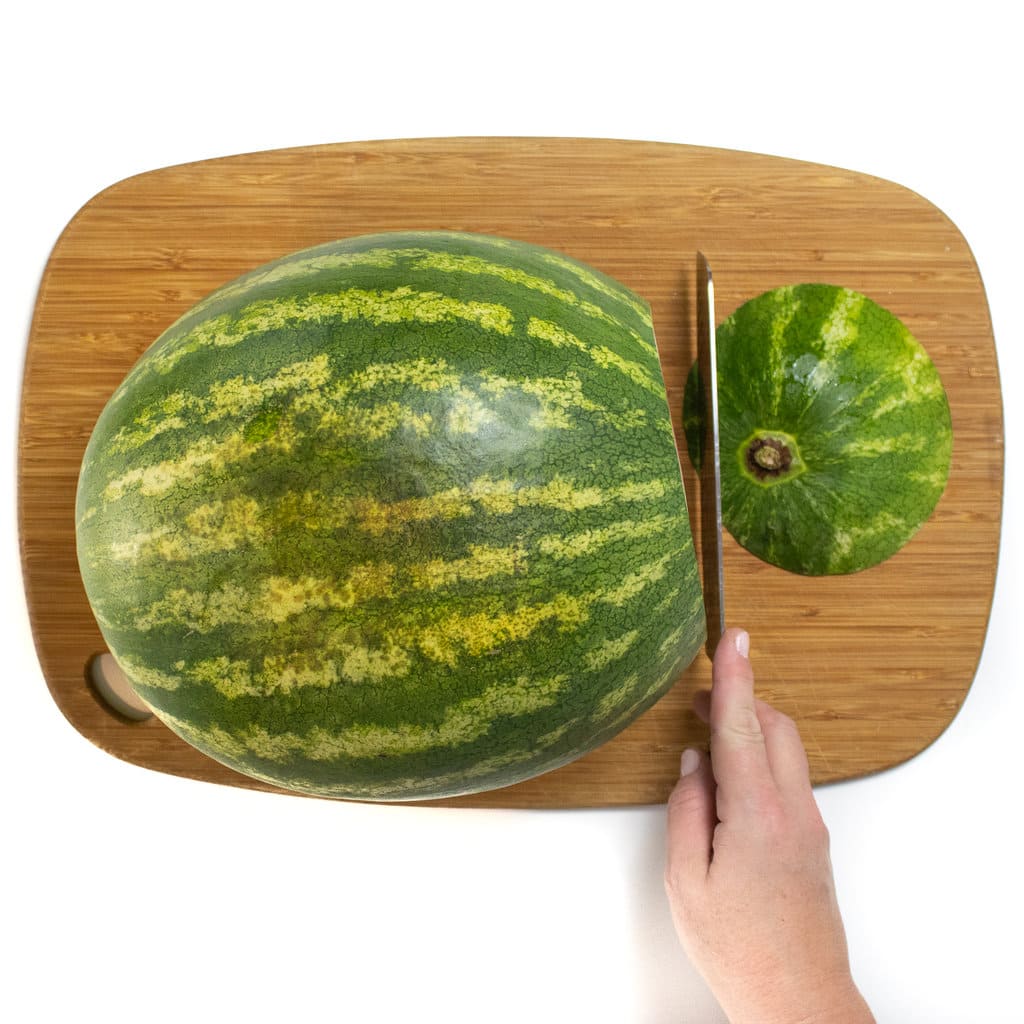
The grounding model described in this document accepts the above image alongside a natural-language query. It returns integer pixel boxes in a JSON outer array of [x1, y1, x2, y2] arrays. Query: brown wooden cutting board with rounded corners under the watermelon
[[18, 138, 1004, 807]]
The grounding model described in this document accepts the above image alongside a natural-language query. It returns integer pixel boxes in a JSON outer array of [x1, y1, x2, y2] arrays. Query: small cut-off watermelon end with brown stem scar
[[683, 284, 952, 575]]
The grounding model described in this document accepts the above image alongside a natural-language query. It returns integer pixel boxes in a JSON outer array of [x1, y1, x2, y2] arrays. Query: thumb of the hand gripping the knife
[[665, 750, 718, 896]]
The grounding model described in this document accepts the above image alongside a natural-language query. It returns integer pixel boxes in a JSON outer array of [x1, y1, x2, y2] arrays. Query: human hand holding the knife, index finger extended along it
[[666, 629, 873, 1024]]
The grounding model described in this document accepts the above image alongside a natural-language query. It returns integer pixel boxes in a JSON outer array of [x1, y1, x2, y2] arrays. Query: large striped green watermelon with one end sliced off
[[76, 231, 705, 801]]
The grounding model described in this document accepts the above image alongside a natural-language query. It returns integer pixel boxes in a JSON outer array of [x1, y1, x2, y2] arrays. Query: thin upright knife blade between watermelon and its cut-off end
[[696, 252, 725, 656]]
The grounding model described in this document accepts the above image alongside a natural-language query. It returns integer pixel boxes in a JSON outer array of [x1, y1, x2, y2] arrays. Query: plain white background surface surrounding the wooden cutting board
[[0, 0, 1024, 1024]]
